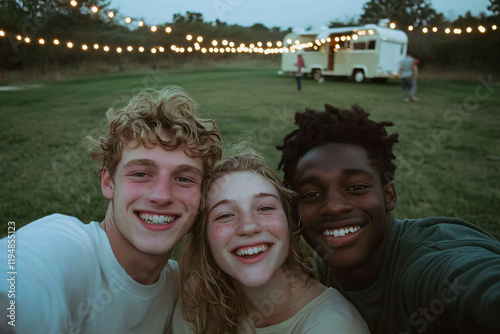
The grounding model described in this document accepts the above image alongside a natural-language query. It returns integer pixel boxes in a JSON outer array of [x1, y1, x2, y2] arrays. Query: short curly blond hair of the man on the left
[[84, 86, 222, 177]]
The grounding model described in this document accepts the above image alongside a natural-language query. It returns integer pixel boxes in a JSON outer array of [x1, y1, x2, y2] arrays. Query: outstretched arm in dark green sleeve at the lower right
[[402, 240, 500, 333]]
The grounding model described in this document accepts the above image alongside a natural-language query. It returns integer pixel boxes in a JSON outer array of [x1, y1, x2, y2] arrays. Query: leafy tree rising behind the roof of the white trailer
[[360, 0, 443, 27]]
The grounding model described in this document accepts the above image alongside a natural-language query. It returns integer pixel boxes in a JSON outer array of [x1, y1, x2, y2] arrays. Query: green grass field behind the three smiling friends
[[0, 64, 500, 238]]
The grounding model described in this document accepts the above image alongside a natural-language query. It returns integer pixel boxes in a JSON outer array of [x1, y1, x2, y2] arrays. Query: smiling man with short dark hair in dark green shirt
[[278, 105, 500, 334]]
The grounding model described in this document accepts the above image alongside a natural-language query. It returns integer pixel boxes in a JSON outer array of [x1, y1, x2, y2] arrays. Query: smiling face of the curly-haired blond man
[[101, 145, 203, 256]]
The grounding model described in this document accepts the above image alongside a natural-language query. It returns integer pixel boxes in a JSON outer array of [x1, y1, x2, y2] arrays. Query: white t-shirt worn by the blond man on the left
[[0, 214, 180, 334]]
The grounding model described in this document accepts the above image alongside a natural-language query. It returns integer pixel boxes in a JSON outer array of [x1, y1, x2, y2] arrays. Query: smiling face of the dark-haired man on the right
[[292, 143, 396, 270]]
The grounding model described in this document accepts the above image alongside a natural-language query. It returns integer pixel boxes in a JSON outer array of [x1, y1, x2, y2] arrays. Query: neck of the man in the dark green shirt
[[333, 220, 394, 291]]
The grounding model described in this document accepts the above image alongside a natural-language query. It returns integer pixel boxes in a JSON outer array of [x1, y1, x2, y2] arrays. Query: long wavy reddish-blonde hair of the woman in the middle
[[179, 152, 315, 334]]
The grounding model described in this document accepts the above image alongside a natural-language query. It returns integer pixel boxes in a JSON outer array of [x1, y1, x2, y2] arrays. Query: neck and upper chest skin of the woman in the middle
[[237, 269, 324, 328]]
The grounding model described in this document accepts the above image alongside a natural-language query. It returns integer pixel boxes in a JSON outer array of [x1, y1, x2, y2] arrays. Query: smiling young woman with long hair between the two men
[[172, 152, 368, 334]]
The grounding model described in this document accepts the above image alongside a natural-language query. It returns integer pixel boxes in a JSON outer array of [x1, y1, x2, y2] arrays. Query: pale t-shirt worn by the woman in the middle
[[172, 288, 370, 334]]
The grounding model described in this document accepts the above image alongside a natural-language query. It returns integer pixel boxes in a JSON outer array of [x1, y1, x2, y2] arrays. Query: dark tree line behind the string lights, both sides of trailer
[[0, 0, 500, 71]]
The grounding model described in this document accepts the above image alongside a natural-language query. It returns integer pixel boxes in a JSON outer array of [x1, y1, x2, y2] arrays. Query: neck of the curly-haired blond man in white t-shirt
[[100, 214, 170, 285]]
